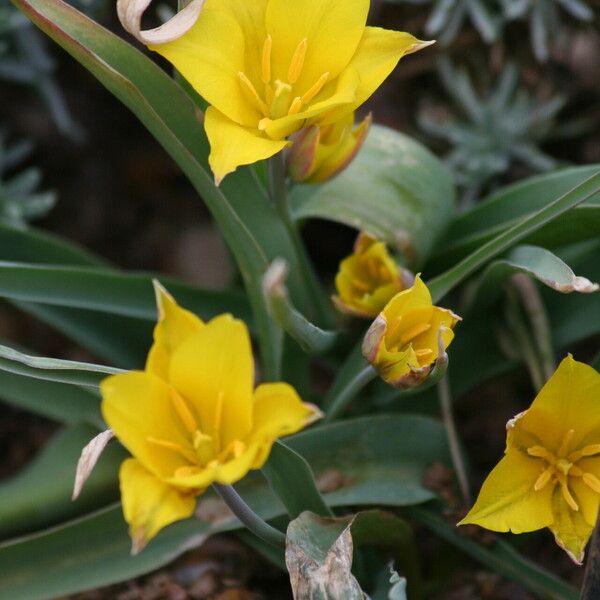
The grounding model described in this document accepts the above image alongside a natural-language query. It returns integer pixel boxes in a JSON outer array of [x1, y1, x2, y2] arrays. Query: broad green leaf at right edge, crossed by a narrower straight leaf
[[428, 165, 600, 272]]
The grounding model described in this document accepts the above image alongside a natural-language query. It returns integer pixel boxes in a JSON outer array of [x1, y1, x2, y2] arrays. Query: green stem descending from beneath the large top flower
[[268, 152, 335, 327]]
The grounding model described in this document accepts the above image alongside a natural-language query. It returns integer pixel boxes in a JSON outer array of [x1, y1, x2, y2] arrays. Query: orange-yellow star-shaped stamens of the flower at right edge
[[527, 429, 600, 511]]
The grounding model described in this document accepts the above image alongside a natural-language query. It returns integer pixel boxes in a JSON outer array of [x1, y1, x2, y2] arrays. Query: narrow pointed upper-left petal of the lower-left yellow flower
[[146, 282, 204, 379]]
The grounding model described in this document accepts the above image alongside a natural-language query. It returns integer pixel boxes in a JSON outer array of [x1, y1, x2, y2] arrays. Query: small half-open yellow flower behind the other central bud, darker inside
[[332, 233, 412, 318]]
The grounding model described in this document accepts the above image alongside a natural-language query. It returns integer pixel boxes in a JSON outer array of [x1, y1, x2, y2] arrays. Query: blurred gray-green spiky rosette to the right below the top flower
[[419, 60, 565, 203]]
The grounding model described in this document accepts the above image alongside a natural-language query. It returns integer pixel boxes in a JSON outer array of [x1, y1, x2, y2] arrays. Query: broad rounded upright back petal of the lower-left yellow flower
[[169, 315, 254, 448]]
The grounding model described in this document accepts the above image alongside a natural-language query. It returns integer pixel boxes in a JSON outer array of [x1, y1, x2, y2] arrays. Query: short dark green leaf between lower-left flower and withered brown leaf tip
[[262, 442, 333, 519]]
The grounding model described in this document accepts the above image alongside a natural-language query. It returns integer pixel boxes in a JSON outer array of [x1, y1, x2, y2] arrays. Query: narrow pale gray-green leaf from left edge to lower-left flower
[[0, 344, 120, 388]]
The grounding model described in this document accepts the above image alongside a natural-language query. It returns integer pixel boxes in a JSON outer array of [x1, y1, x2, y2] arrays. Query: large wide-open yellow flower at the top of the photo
[[149, 0, 428, 184]]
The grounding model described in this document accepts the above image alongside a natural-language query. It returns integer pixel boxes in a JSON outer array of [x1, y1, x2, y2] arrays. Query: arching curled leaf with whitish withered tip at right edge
[[470, 246, 598, 312]]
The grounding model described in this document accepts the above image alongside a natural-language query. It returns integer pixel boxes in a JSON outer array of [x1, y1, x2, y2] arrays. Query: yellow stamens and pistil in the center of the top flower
[[238, 34, 329, 129]]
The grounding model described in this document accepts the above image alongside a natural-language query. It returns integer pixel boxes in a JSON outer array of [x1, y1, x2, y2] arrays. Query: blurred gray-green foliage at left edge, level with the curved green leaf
[[0, 133, 56, 227]]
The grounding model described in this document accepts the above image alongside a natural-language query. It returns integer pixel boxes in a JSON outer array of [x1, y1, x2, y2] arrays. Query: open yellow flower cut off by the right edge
[[459, 355, 600, 563]]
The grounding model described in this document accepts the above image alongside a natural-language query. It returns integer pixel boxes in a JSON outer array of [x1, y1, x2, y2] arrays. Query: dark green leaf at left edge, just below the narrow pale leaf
[[0, 371, 103, 427]]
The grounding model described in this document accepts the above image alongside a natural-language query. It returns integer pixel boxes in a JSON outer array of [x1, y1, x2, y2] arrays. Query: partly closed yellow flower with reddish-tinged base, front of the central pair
[[363, 275, 461, 389]]
